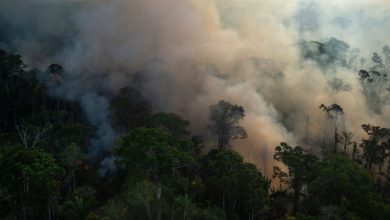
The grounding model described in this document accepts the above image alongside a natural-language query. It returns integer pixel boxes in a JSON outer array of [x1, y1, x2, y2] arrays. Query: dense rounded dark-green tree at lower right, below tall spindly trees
[[308, 154, 371, 219]]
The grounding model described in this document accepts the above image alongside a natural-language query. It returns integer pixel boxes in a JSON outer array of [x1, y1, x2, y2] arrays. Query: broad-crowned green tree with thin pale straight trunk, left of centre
[[115, 128, 194, 220]]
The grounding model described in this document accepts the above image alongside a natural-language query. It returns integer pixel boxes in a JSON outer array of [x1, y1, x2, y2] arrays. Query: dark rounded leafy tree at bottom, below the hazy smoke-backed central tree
[[202, 150, 268, 219]]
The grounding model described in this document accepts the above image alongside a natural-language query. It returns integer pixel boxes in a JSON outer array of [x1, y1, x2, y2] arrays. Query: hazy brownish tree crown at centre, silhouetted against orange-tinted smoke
[[208, 100, 248, 149]]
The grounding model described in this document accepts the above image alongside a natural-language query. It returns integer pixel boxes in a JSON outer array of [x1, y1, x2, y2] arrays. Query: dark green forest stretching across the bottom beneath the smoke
[[0, 48, 390, 220]]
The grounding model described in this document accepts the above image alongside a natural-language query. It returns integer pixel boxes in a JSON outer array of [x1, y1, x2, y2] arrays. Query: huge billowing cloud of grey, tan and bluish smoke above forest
[[0, 0, 390, 173]]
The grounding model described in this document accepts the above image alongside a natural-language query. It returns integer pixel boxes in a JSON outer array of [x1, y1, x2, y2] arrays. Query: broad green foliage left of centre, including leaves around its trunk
[[115, 128, 195, 219]]
